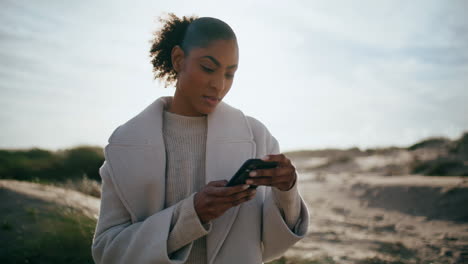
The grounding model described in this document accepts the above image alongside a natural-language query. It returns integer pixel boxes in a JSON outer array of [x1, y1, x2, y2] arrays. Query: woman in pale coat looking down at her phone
[[92, 14, 309, 264]]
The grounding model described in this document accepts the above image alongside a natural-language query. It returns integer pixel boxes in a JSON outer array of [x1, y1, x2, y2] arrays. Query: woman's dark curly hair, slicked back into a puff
[[149, 13, 236, 87]]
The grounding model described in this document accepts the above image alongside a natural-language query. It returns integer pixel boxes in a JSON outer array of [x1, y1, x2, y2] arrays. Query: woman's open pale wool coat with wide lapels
[[92, 97, 309, 264]]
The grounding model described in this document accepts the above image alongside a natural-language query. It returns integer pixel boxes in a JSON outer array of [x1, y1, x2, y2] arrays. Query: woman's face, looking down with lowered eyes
[[170, 40, 239, 116]]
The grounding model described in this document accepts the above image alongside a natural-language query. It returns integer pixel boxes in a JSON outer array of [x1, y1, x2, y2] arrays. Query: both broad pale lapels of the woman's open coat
[[106, 97, 256, 263]]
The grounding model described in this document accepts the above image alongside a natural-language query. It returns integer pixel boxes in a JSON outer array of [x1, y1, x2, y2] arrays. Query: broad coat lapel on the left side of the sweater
[[104, 98, 167, 222]]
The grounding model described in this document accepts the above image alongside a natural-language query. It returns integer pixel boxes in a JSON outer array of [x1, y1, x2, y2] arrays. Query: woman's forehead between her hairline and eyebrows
[[189, 40, 239, 66]]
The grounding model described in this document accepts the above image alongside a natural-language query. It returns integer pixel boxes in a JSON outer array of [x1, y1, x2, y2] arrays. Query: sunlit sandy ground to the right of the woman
[[286, 172, 468, 263]]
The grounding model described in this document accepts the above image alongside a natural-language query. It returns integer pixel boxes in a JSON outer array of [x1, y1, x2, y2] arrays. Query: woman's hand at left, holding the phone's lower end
[[194, 180, 256, 224]]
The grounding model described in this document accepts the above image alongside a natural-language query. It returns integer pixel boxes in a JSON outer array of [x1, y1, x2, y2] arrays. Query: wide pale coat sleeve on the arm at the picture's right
[[262, 133, 309, 262]]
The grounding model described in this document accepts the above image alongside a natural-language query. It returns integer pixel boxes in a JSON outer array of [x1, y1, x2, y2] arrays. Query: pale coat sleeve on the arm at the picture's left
[[92, 161, 201, 264]]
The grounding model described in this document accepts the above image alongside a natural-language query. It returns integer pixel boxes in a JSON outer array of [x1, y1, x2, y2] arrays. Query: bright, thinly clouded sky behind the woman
[[0, 0, 468, 150]]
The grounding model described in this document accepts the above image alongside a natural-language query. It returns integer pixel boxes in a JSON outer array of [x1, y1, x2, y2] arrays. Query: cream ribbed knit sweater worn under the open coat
[[163, 110, 300, 264]]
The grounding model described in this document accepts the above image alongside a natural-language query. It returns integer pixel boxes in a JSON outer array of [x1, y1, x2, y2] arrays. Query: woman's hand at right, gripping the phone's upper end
[[246, 154, 297, 191]]
